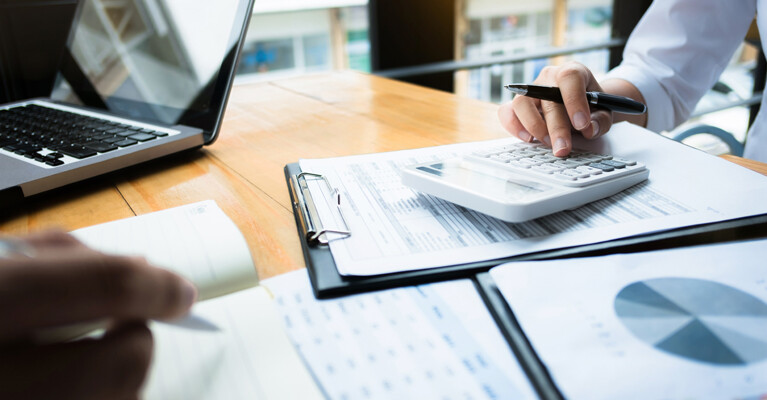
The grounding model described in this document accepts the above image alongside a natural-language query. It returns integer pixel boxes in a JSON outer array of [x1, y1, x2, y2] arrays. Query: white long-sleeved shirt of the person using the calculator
[[608, 0, 767, 162]]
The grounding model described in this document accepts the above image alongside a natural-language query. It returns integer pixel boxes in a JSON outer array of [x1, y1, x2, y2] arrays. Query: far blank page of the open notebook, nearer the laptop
[[72, 200, 258, 300]]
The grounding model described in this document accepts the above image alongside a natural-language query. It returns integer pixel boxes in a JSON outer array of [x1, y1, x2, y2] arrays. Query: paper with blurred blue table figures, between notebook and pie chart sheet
[[263, 271, 537, 400]]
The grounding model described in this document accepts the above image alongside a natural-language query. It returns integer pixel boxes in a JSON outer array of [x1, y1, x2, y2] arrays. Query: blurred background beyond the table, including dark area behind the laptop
[[0, 0, 765, 154]]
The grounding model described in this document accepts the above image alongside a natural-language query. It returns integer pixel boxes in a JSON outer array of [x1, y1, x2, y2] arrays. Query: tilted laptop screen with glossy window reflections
[[52, 0, 253, 142]]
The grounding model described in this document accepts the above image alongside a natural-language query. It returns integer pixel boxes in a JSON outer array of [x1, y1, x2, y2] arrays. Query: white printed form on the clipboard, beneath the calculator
[[300, 124, 767, 276]]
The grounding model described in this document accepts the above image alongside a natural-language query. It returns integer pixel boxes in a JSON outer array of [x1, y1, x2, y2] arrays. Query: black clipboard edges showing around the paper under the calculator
[[285, 163, 767, 299]]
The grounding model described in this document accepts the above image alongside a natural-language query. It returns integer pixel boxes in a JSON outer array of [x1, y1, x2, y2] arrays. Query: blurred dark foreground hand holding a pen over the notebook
[[0, 232, 197, 399]]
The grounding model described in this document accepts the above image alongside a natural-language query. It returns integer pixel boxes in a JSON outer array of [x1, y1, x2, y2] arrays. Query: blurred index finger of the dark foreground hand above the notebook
[[0, 248, 197, 338]]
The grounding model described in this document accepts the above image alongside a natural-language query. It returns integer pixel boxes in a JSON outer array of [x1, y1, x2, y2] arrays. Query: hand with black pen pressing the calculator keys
[[498, 62, 647, 157]]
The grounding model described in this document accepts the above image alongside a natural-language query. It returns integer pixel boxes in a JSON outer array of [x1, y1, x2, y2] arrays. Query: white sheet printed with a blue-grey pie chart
[[490, 240, 767, 400]]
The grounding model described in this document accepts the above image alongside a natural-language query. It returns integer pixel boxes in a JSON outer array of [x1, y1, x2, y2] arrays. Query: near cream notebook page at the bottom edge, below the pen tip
[[142, 287, 324, 400]]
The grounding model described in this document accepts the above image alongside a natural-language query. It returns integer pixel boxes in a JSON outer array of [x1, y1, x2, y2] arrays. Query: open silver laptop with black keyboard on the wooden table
[[0, 0, 254, 203]]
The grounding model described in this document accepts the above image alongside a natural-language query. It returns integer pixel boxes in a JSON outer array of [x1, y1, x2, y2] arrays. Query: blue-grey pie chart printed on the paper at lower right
[[614, 278, 767, 366]]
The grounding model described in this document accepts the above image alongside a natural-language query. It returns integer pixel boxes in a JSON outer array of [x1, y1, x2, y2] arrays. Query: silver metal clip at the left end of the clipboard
[[290, 172, 352, 245]]
